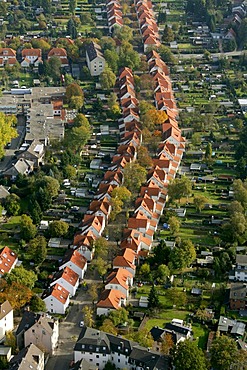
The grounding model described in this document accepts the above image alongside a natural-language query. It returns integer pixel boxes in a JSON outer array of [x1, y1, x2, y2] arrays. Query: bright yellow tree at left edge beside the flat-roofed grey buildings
[[0, 112, 18, 159]]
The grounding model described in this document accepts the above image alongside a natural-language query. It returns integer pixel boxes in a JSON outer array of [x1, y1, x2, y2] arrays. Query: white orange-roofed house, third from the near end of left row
[[59, 249, 87, 279]]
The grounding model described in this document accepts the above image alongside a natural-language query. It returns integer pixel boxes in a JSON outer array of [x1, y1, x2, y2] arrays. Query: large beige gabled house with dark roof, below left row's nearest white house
[[15, 311, 59, 354]]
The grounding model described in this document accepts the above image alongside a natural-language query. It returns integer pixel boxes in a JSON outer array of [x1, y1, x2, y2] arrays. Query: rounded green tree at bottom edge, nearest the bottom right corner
[[210, 335, 238, 370]]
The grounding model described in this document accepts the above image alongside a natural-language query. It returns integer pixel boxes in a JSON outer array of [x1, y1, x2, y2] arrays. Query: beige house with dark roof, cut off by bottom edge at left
[[8, 343, 45, 370]]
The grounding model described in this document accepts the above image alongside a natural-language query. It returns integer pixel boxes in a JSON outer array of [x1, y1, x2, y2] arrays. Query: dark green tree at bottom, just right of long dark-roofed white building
[[172, 340, 207, 370]]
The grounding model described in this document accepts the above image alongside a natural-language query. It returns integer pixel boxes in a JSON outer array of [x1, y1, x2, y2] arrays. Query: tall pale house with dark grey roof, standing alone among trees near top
[[86, 41, 105, 76]]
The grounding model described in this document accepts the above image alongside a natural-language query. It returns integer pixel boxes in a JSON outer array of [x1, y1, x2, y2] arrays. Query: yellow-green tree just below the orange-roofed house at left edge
[[4, 265, 38, 289]]
